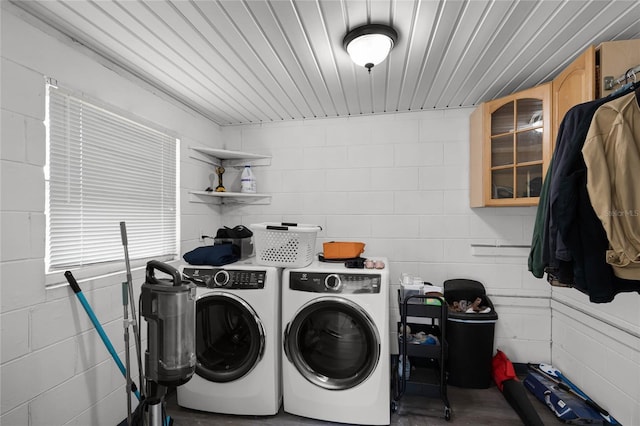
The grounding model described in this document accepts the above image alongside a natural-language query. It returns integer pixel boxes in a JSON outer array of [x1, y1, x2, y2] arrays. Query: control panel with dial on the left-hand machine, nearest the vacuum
[[182, 268, 267, 290]]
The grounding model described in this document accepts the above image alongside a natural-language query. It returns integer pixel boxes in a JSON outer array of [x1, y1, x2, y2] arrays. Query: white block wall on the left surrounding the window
[[0, 7, 222, 426]]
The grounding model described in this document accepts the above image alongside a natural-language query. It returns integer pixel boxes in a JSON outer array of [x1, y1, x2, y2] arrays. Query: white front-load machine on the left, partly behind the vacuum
[[177, 259, 282, 415]]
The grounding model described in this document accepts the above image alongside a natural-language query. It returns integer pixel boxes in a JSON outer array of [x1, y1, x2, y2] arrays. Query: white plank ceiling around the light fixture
[[13, 0, 640, 125]]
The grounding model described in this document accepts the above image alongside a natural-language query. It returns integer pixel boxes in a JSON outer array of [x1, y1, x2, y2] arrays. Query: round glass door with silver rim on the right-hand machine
[[284, 296, 380, 390]]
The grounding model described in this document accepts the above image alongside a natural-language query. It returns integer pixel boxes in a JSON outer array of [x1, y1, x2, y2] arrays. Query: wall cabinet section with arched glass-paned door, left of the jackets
[[470, 83, 552, 207]]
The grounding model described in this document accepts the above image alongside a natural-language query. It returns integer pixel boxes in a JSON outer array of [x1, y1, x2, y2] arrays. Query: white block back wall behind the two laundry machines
[[223, 109, 551, 361]]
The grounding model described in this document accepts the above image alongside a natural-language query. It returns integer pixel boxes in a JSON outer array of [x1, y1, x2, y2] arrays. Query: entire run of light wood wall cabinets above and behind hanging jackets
[[469, 39, 640, 207]]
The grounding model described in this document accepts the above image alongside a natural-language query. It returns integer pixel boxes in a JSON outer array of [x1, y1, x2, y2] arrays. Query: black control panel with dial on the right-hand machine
[[289, 271, 382, 294]]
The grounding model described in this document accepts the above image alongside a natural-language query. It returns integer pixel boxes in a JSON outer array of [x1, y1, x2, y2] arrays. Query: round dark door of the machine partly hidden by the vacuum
[[196, 291, 265, 383]]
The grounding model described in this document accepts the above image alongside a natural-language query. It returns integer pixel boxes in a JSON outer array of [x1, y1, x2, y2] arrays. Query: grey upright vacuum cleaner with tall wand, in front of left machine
[[120, 222, 196, 426]]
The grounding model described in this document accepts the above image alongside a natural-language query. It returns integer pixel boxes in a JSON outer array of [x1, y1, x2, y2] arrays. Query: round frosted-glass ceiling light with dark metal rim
[[342, 24, 398, 73]]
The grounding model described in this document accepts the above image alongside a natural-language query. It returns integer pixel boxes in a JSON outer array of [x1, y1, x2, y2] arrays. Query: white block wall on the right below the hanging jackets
[[551, 288, 640, 425]]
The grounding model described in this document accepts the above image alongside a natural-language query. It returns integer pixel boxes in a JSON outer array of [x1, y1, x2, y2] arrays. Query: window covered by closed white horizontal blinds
[[45, 85, 179, 272]]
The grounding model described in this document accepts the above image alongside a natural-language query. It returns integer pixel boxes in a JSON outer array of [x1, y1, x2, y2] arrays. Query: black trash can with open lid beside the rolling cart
[[444, 279, 498, 389]]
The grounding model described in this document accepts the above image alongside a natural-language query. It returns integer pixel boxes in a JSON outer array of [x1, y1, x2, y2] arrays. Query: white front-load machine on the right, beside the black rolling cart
[[282, 259, 391, 425]]
